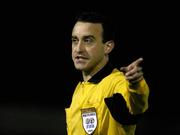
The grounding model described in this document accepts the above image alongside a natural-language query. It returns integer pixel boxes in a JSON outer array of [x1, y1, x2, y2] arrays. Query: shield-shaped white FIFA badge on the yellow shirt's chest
[[81, 107, 97, 135]]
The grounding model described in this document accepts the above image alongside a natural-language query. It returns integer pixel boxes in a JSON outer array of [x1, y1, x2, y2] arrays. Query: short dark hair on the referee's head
[[75, 11, 115, 43]]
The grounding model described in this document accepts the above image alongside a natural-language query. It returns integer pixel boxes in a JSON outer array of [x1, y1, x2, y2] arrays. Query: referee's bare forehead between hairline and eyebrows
[[72, 22, 102, 37]]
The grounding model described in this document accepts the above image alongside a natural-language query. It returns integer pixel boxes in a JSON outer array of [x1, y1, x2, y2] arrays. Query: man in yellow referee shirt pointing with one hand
[[66, 12, 149, 135]]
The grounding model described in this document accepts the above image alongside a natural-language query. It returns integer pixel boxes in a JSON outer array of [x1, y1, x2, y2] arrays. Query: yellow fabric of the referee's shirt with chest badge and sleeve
[[65, 66, 149, 135]]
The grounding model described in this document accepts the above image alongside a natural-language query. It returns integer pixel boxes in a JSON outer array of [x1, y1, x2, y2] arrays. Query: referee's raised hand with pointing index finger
[[120, 58, 143, 83]]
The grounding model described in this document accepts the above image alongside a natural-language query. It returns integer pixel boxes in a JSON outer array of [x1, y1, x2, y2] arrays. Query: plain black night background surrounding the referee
[[0, 3, 180, 135]]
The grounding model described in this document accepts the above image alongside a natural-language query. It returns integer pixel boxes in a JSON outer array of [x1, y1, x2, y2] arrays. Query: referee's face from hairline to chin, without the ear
[[72, 22, 107, 73]]
